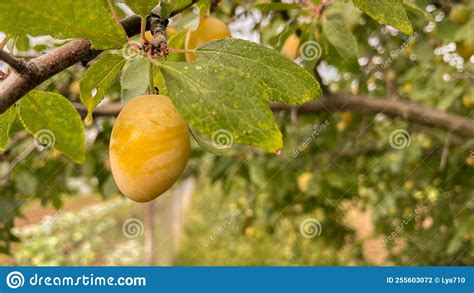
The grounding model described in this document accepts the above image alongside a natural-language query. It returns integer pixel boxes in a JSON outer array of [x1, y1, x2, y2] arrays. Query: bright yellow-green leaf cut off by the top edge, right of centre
[[352, 0, 413, 35]]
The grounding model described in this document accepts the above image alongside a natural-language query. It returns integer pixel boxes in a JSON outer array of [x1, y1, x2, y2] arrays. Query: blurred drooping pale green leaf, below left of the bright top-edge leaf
[[323, 16, 359, 63]]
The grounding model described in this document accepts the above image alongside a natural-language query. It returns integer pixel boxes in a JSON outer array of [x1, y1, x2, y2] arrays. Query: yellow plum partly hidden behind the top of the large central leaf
[[184, 17, 230, 62]]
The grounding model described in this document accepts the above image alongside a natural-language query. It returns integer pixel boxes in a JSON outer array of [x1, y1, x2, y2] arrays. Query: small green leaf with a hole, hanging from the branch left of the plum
[[81, 54, 126, 117]]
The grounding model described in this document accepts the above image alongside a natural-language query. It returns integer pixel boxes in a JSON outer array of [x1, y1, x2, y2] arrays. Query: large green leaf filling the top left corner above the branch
[[0, 0, 127, 50]]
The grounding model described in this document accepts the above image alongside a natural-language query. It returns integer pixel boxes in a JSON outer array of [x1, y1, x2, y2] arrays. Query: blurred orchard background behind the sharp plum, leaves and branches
[[0, 0, 474, 265]]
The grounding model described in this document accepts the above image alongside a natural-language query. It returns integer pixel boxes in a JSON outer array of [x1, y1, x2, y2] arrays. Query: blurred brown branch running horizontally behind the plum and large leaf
[[74, 94, 474, 138]]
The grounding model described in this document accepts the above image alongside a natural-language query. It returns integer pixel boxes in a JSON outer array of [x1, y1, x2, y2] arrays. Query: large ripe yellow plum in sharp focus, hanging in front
[[109, 95, 190, 202]]
